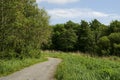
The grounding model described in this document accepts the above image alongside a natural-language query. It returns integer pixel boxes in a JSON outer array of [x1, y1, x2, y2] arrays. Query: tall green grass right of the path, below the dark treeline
[[43, 53, 120, 80]]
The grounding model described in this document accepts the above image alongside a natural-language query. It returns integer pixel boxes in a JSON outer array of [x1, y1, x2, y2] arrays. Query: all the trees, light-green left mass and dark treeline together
[[0, 0, 120, 59]]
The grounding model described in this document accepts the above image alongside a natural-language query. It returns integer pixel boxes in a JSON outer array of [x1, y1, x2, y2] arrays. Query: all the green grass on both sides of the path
[[0, 52, 120, 80]]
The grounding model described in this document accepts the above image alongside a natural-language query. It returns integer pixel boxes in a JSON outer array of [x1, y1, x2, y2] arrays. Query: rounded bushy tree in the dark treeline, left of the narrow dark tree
[[58, 29, 77, 51]]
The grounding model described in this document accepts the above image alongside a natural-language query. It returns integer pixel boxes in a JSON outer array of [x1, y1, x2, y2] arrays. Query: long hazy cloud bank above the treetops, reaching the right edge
[[47, 8, 120, 21]]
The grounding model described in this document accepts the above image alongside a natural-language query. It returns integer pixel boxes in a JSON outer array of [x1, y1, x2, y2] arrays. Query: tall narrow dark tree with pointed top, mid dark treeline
[[77, 20, 93, 52]]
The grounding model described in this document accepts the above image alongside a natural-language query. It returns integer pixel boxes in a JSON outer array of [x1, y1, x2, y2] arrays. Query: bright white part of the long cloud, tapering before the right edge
[[47, 8, 109, 18]]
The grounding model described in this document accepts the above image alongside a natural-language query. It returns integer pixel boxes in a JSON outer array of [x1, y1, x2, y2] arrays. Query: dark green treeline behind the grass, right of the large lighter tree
[[49, 19, 120, 56]]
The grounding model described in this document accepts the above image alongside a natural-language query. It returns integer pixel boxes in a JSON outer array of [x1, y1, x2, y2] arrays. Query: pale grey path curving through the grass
[[0, 58, 61, 80]]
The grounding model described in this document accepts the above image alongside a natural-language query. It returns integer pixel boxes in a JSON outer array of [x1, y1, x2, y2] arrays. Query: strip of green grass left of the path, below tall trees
[[0, 55, 47, 77]]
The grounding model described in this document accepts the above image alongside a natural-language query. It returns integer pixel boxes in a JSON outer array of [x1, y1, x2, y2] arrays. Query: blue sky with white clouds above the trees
[[36, 0, 120, 24]]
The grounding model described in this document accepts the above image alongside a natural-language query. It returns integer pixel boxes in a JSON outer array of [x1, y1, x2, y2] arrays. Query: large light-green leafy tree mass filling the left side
[[0, 0, 51, 59]]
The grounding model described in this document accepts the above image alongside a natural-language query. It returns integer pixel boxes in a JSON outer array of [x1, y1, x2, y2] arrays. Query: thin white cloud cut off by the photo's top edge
[[36, 0, 79, 4]]
